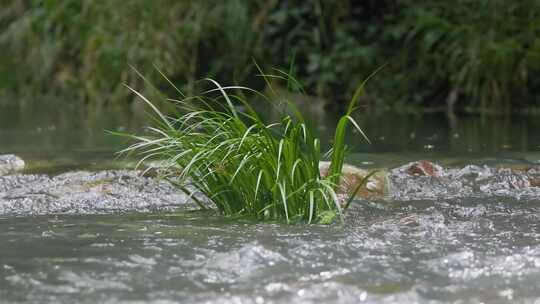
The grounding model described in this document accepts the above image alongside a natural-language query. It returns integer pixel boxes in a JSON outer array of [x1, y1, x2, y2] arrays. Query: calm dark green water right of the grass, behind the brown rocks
[[350, 113, 540, 154]]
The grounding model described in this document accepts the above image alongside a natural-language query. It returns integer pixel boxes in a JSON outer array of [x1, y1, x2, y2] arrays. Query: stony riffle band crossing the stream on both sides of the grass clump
[[0, 161, 540, 215]]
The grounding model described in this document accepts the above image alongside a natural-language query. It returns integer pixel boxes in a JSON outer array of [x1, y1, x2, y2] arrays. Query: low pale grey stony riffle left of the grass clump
[[0, 170, 188, 215]]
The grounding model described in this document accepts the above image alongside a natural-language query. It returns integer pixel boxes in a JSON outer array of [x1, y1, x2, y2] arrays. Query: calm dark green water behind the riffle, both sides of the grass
[[0, 101, 540, 170]]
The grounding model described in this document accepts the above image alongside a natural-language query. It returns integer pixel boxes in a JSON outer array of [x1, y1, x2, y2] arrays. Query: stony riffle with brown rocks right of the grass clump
[[319, 160, 540, 201]]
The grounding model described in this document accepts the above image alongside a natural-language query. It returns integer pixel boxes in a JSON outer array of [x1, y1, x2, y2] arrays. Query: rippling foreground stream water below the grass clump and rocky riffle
[[0, 198, 540, 303]]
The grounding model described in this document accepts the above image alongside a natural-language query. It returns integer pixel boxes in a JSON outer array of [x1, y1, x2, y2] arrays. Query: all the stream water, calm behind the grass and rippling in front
[[0, 101, 540, 304]]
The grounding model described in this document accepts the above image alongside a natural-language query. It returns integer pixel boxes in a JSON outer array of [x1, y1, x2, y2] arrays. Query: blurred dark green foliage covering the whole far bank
[[0, 0, 540, 110]]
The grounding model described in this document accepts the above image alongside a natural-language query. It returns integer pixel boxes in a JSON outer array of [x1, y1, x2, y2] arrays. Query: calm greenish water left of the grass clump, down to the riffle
[[0, 100, 147, 172]]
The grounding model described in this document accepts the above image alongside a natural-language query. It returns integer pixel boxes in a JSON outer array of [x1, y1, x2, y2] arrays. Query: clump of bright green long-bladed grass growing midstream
[[124, 71, 372, 223]]
